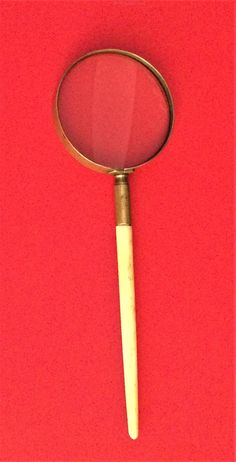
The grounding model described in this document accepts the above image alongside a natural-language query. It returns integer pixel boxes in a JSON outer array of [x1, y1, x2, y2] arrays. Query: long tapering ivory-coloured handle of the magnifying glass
[[116, 225, 138, 439]]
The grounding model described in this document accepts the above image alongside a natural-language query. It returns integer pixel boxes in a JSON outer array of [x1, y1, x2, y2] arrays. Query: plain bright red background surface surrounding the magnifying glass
[[0, 1, 233, 462]]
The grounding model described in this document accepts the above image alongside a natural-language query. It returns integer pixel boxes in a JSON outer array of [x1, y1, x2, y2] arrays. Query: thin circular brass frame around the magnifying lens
[[53, 48, 174, 175]]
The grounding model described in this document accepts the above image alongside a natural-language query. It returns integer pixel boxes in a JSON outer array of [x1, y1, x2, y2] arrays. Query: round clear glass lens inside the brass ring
[[58, 52, 170, 169]]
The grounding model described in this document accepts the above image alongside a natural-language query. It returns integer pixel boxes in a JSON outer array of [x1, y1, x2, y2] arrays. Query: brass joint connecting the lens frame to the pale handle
[[115, 173, 131, 226]]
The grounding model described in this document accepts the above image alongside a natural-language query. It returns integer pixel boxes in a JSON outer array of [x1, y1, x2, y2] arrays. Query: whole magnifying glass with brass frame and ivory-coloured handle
[[54, 49, 173, 439]]
